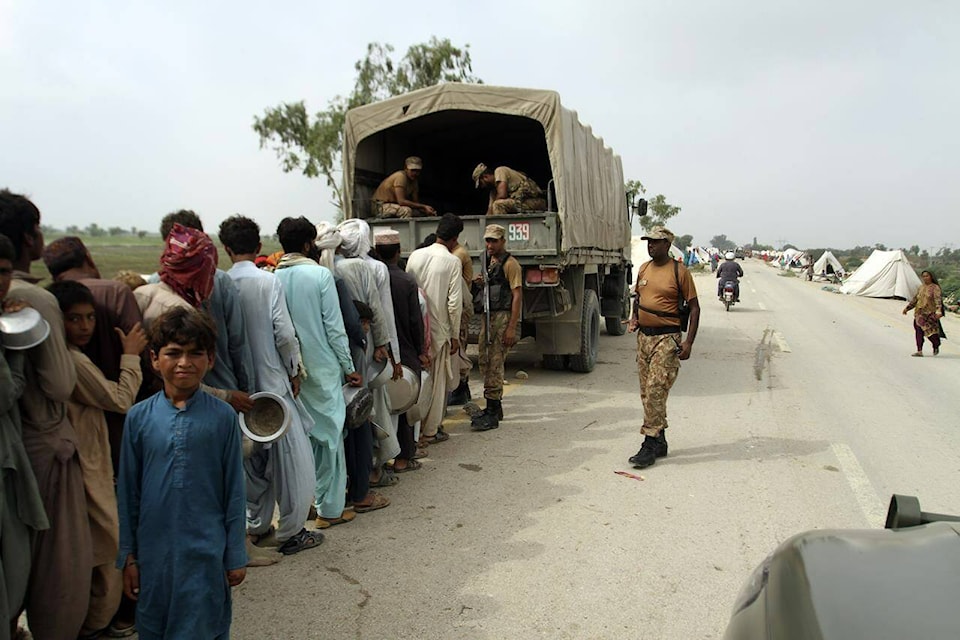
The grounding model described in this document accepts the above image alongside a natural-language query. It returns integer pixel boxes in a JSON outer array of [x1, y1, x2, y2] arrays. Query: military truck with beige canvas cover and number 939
[[343, 83, 632, 372]]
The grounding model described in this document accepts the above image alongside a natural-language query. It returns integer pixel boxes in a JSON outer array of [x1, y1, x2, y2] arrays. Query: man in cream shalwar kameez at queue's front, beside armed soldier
[[407, 213, 463, 444]]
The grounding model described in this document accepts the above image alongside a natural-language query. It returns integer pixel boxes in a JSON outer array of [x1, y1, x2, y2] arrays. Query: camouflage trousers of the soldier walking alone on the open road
[[637, 332, 680, 437]]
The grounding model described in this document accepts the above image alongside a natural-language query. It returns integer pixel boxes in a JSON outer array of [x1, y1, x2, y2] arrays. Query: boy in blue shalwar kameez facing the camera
[[117, 308, 247, 640]]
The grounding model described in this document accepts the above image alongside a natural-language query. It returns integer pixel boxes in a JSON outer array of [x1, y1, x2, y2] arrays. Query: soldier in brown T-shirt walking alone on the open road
[[630, 227, 700, 469]]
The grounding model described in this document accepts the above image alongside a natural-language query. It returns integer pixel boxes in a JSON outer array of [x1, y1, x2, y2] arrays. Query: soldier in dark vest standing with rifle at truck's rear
[[470, 224, 523, 431]]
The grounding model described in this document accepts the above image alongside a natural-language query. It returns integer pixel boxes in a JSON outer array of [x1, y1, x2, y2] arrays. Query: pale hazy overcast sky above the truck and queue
[[0, 0, 960, 247]]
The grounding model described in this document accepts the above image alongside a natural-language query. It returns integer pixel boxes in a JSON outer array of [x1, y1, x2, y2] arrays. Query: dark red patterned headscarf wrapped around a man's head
[[160, 223, 217, 307]]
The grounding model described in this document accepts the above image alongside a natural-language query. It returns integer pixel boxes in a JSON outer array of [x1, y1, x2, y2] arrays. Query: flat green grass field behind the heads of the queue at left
[[31, 233, 280, 284]]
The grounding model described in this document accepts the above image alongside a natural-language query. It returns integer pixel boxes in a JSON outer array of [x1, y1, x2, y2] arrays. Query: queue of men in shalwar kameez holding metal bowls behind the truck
[[0, 188, 521, 640]]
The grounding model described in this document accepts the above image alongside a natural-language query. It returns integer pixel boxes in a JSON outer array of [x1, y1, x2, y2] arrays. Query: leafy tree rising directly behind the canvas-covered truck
[[253, 36, 481, 210]]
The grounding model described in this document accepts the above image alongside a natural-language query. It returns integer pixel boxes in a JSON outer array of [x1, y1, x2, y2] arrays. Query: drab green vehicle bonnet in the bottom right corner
[[723, 495, 960, 640]]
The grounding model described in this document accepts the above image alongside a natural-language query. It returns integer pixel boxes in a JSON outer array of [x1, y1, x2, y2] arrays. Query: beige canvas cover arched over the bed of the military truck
[[343, 83, 630, 251]]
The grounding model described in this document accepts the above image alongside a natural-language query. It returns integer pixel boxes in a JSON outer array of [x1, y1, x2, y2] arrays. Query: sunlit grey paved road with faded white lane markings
[[233, 260, 960, 640]]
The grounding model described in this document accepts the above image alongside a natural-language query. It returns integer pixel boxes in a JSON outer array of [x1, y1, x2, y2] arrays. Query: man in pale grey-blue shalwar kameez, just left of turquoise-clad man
[[220, 216, 323, 555]]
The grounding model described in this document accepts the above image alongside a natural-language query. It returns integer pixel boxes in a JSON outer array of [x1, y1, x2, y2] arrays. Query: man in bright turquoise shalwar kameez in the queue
[[276, 217, 362, 521]]
